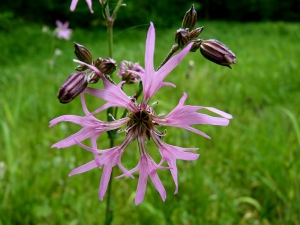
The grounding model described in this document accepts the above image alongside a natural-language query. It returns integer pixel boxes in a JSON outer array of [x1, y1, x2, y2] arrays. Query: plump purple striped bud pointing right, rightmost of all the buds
[[200, 39, 236, 69]]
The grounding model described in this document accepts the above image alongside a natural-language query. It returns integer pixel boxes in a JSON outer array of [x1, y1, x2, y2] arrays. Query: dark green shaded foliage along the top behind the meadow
[[0, 0, 300, 28]]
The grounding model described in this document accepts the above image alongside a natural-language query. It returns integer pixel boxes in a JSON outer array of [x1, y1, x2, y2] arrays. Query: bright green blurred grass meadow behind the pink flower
[[0, 22, 300, 225]]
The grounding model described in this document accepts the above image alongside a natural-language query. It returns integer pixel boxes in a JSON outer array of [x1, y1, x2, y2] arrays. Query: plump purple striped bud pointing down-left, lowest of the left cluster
[[57, 72, 87, 103]]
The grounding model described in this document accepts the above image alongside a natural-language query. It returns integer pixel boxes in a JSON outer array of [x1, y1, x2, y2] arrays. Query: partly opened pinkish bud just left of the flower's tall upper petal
[[117, 60, 145, 84]]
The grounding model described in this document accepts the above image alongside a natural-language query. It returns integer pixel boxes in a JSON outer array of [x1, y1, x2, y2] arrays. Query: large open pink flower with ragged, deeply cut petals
[[50, 23, 232, 205]]
